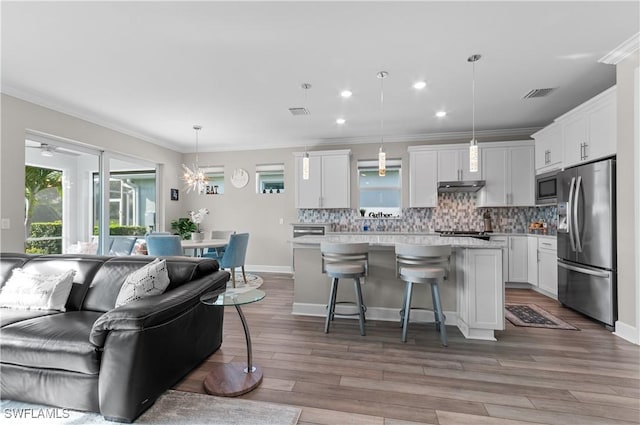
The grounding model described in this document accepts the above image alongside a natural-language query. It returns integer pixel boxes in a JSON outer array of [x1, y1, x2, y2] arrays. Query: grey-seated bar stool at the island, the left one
[[320, 242, 369, 336]]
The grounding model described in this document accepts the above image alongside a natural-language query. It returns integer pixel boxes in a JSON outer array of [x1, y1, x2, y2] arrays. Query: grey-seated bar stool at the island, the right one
[[396, 244, 451, 347]]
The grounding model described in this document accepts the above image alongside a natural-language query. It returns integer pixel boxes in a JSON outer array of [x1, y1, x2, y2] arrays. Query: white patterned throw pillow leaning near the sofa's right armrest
[[116, 258, 169, 307]]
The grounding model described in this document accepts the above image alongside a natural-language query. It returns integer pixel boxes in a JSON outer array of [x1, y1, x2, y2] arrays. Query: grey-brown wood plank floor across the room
[[175, 273, 640, 425]]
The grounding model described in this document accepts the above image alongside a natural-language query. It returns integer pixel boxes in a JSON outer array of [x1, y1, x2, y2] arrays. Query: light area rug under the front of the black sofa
[[0, 390, 301, 425]]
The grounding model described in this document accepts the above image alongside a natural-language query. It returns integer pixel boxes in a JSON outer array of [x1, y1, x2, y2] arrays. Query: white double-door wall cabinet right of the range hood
[[476, 141, 535, 207]]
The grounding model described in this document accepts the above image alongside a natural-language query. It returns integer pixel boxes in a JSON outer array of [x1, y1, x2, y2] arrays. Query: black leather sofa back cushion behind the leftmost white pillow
[[22, 254, 109, 310]]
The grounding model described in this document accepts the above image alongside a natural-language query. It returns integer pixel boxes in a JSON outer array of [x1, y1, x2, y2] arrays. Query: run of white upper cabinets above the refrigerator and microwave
[[532, 86, 616, 174]]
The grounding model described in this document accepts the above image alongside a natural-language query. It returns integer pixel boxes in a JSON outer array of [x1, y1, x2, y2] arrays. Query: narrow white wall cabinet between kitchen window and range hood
[[409, 149, 438, 208]]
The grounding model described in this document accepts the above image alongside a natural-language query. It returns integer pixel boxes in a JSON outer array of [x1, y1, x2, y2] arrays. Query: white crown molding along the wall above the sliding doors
[[0, 85, 182, 153]]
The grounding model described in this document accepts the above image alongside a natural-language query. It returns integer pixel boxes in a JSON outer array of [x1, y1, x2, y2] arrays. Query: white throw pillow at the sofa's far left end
[[0, 268, 76, 311]]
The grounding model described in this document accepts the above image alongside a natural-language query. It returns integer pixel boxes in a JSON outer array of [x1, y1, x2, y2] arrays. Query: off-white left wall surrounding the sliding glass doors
[[0, 94, 184, 252]]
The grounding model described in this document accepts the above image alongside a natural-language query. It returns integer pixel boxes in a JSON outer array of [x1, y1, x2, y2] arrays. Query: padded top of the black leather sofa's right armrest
[[89, 271, 230, 347]]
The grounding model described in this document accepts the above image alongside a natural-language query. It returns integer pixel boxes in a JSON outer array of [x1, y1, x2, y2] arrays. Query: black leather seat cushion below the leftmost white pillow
[[0, 311, 101, 374]]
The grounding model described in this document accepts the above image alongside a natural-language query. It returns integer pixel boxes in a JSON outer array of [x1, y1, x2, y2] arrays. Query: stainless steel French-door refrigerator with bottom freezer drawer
[[558, 158, 618, 330]]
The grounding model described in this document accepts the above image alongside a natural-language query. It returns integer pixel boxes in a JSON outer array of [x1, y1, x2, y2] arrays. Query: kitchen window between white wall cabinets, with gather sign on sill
[[358, 159, 402, 218]]
